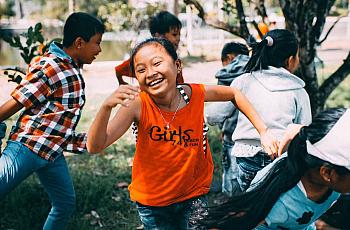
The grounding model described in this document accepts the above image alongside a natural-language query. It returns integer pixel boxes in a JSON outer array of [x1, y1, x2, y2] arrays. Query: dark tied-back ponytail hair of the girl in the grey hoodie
[[245, 29, 298, 73]]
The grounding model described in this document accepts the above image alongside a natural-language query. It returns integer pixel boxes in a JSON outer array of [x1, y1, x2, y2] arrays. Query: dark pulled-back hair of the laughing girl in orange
[[130, 37, 178, 77]]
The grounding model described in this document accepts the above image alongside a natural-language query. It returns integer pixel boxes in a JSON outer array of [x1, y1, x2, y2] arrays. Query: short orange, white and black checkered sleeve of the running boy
[[11, 69, 51, 108]]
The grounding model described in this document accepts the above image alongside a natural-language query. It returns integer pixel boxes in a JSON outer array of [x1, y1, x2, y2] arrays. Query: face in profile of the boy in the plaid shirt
[[77, 33, 102, 65]]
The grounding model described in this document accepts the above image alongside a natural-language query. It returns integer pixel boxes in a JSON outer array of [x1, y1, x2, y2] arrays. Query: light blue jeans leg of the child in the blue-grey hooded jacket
[[222, 141, 240, 196]]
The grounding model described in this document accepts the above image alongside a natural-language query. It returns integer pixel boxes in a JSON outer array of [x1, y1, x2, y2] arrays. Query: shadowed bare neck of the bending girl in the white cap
[[301, 169, 329, 202]]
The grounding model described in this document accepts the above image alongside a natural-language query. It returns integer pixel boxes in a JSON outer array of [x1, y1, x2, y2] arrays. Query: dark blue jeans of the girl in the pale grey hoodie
[[236, 152, 272, 192]]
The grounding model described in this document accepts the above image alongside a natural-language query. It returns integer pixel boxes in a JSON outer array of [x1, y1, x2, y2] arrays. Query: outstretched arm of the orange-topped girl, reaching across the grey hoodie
[[205, 85, 278, 158]]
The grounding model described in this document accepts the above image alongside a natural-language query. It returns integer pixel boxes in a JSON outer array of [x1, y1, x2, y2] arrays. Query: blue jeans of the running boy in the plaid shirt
[[0, 141, 75, 230]]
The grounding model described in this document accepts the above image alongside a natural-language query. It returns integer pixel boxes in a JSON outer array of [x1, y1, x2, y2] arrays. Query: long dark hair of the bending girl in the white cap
[[205, 109, 349, 230]]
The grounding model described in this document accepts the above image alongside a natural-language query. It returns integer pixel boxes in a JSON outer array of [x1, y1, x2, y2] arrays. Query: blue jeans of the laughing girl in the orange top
[[136, 196, 208, 230]]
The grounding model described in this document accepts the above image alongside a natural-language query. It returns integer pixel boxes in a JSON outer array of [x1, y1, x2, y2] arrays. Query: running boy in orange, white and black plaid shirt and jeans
[[0, 12, 104, 229]]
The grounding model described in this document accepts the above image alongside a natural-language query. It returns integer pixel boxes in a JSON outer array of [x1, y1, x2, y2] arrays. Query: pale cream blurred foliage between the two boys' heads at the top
[[97, 1, 164, 31]]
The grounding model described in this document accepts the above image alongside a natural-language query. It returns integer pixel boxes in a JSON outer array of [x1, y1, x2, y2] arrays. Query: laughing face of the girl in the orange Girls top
[[134, 42, 179, 96]]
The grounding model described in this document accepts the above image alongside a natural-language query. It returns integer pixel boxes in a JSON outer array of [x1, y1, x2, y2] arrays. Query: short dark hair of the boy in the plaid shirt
[[63, 12, 105, 47]]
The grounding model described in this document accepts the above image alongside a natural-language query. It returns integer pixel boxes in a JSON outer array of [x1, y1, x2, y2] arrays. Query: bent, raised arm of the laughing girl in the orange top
[[86, 85, 140, 153]]
